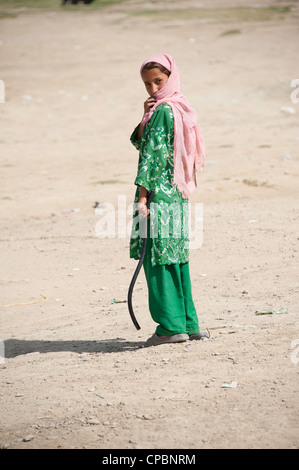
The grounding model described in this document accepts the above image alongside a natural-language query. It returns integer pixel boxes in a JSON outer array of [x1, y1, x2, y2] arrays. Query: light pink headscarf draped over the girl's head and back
[[140, 54, 205, 199]]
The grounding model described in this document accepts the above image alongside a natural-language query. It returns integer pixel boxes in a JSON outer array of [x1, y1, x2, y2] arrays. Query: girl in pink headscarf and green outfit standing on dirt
[[130, 54, 205, 346]]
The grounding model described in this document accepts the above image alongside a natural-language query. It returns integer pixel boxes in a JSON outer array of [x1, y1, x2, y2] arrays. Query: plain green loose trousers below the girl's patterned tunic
[[143, 223, 199, 336]]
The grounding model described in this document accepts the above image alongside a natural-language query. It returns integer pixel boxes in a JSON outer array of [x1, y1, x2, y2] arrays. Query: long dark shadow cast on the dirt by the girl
[[4, 338, 144, 358]]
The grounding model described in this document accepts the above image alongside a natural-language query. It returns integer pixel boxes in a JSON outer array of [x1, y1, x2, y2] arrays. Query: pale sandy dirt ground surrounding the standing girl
[[0, 0, 299, 449]]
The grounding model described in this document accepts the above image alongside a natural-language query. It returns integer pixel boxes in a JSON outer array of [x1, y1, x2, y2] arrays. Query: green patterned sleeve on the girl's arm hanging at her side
[[135, 105, 173, 191]]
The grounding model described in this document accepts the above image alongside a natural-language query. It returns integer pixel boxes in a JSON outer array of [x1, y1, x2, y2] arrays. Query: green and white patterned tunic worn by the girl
[[130, 103, 189, 266]]
